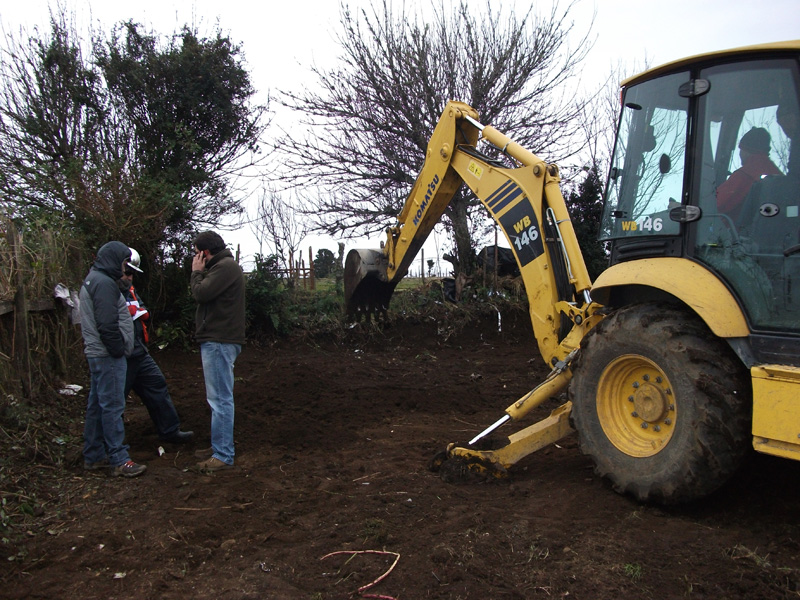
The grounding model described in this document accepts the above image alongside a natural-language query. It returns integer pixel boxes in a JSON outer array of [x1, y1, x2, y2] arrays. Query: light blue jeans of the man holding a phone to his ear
[[200, 342, 242, 465]]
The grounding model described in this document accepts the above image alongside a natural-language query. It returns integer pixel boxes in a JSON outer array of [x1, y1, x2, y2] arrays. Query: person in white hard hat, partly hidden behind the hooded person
[[119, 248, 194, 444]]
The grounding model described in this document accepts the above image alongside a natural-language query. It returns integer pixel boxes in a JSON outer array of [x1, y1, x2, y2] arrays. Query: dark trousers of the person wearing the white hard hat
[[125, 354, 181, 439]]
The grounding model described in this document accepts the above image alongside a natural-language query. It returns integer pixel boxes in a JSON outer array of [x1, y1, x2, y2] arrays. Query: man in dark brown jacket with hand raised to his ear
[[190, 231, 245, 472]]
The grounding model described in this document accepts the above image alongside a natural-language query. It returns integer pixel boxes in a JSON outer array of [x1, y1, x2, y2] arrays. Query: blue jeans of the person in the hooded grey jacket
[[83, 356, 130, 467]]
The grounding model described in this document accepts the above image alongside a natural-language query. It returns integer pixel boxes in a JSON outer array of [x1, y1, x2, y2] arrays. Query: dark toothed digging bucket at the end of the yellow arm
[[344, 250, 397, 320]]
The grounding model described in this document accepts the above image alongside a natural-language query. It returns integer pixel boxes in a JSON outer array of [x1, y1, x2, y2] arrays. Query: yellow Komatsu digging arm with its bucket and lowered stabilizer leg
[[345, 102, 602, 472]]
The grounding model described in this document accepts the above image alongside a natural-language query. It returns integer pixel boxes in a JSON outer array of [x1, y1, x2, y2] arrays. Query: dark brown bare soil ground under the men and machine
[[0, 317, 800, 600]]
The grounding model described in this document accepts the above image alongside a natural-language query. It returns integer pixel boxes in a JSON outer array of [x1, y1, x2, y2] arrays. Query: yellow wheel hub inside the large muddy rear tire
[[597, 354, 677, 457]]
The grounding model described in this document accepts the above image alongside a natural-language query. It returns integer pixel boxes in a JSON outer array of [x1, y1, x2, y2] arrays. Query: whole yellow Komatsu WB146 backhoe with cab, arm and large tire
[[345, 40, 800, 504]]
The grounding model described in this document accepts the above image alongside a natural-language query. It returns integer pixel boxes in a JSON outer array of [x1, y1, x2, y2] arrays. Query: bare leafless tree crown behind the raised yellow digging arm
[[278, 0, 591, 274]]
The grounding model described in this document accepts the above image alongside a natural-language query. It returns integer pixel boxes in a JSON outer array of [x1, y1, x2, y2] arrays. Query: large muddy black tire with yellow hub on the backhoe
[[570, 304, 752, 504]]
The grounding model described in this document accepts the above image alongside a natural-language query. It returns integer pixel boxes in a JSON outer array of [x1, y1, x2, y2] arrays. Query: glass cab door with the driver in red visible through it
[[687, 57, 800, 344]]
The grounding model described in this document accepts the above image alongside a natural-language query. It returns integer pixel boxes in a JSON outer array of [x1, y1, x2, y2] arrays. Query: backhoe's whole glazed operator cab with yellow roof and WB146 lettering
[[600, 42, 800, 360]]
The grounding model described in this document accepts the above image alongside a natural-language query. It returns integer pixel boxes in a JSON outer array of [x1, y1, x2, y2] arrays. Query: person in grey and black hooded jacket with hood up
[[79, 241, 147, 477]]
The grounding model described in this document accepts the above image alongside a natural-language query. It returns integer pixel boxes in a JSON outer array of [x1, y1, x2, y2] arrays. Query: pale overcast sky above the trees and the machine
[[0, 0, 800, 268]]
